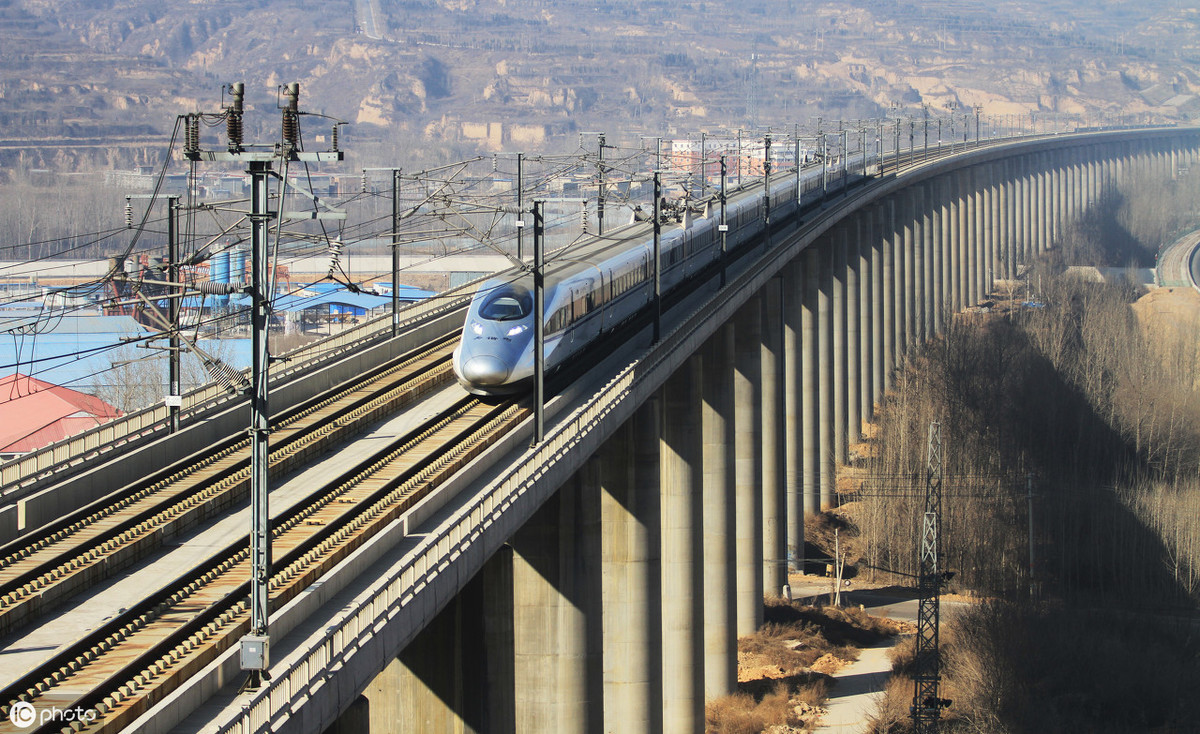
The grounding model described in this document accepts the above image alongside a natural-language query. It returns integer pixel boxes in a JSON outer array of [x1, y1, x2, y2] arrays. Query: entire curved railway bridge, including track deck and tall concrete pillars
[[0, 128, 1200, 734]]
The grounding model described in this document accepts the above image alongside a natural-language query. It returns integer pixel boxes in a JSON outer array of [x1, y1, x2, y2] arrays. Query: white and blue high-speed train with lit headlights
[[454, 157, 866, 396]]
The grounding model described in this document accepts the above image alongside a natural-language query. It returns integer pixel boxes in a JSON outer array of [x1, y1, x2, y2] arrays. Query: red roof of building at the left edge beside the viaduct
[[0, 373, 121, 458]]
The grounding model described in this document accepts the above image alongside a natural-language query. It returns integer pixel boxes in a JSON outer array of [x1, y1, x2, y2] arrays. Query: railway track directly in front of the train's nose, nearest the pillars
[[0, 383, 527, 733]]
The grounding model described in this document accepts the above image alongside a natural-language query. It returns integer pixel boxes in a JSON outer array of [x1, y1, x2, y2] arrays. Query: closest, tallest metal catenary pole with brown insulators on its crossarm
[[184, 83, 345, 686]]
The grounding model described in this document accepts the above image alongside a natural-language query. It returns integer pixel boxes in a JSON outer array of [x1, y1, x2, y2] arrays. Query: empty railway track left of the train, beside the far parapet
[[0, 338, 454, 636]]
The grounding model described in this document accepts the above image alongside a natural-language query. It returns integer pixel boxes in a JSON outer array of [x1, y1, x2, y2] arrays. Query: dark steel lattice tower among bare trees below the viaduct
[[910, 422, 949, 734]]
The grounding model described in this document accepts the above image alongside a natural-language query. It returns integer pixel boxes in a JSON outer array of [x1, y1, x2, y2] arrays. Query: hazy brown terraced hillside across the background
[[0, 0, 1200, 170]]
